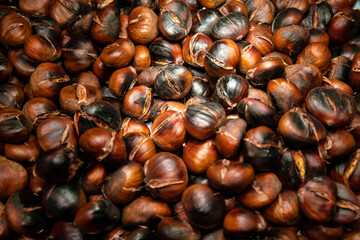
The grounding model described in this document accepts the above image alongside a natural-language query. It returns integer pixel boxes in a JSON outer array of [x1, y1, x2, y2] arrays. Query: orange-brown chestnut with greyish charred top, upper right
[[272, 24, 310, 57]]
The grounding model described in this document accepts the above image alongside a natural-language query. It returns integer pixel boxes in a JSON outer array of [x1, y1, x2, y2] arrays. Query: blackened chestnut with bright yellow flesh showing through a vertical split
[[277, 149, 327, 190]]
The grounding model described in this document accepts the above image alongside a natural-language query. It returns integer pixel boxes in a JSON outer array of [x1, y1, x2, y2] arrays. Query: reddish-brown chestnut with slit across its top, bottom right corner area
[[297, 176, 337, 223]]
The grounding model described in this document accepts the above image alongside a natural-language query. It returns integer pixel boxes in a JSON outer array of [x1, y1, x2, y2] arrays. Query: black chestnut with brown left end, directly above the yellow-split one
[[278, 108, 326, 148]]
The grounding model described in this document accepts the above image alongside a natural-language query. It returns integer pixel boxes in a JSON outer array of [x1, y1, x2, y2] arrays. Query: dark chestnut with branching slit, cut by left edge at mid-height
[[0, 107, 32, 143]]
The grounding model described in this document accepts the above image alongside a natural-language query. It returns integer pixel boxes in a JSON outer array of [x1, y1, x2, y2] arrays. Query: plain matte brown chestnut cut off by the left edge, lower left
[[0, 156, 28, 200]]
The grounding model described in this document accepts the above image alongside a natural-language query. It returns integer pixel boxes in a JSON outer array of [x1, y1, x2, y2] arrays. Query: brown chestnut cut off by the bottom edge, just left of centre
[[157, 217, 201, 240]]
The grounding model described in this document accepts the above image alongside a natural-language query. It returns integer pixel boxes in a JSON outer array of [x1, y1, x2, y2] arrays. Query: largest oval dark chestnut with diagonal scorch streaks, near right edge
[[305, 87, 357, 128]]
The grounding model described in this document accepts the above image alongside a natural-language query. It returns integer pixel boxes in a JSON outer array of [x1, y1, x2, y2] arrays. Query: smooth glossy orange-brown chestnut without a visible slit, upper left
[[100, 38, 135, 68]]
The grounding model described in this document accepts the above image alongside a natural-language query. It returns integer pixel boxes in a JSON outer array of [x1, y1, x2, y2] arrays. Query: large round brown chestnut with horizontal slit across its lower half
[[144, 152, 188, 202]]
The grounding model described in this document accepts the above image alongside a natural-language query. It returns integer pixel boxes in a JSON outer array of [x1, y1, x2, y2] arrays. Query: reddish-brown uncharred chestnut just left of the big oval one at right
[[267, 78, 301, 113]]
